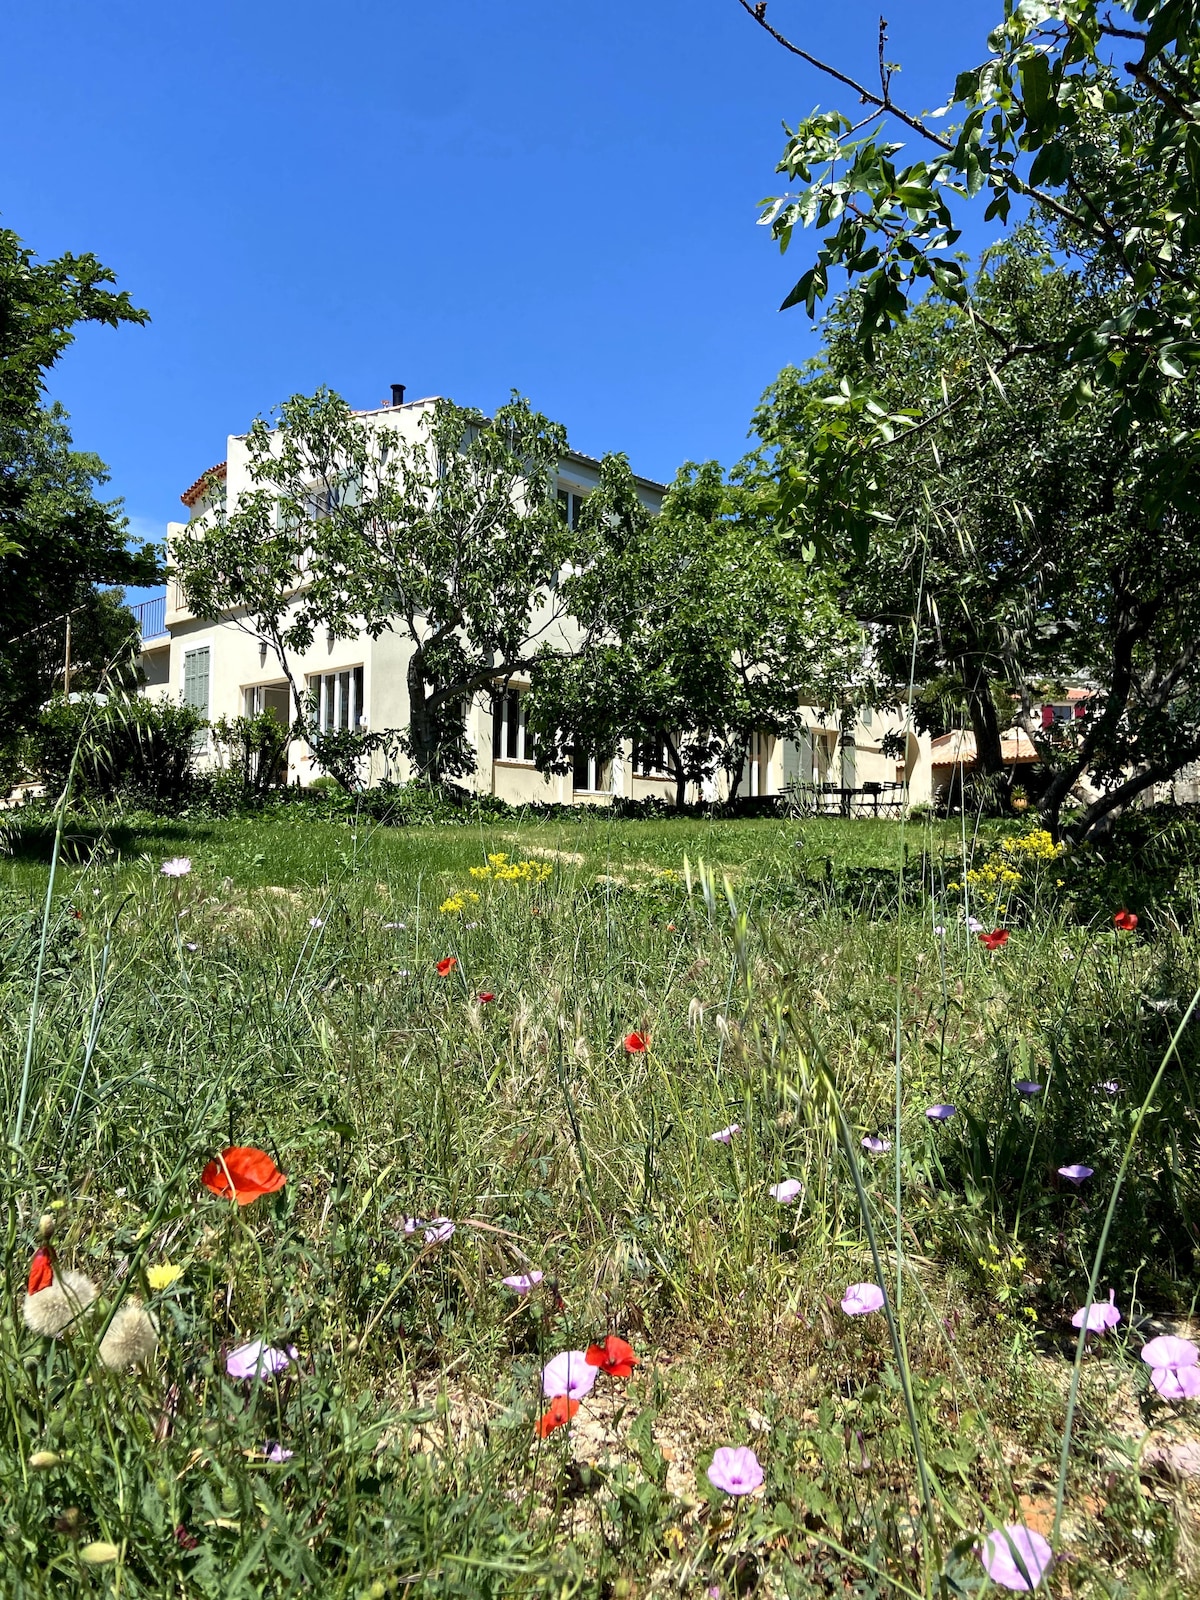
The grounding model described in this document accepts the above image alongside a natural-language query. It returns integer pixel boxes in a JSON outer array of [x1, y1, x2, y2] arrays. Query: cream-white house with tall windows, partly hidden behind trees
[[134, 384, 931, 810]]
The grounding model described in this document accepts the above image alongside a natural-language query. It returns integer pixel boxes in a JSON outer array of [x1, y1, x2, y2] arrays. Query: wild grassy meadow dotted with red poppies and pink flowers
[[0, 816, 1200, 1600]]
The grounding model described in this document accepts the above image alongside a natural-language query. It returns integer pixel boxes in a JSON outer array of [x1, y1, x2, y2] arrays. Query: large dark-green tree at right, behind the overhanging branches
[[757, 227, 1200, 837]]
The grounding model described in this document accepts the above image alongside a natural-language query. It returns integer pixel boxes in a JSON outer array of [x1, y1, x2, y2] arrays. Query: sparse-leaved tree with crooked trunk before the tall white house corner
[[173, 389, 578, 781]]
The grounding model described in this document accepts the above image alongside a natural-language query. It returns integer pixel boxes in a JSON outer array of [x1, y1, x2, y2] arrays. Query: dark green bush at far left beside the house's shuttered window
[[26, 694, 205, 808]]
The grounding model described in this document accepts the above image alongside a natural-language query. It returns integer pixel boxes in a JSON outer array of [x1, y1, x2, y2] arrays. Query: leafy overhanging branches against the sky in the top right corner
[[739, 0, 1200, 422]]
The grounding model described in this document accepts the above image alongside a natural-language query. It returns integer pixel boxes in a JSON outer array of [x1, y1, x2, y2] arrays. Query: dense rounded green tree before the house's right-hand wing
[[530, 458, 862, 805]]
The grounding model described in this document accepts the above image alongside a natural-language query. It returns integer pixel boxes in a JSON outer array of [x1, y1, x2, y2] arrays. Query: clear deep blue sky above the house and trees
[[0, 0, 1000, 588]]
